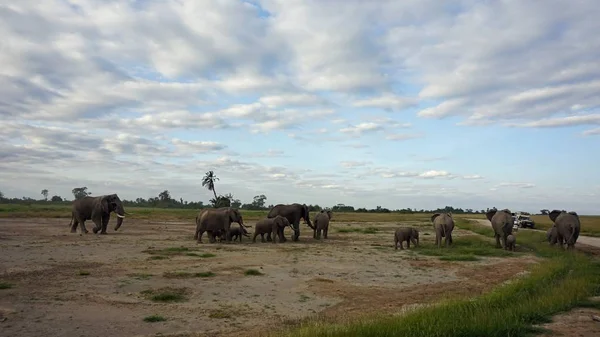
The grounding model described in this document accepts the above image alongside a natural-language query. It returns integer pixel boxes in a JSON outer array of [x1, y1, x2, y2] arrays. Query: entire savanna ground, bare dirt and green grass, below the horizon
[[0, 205, 600, 336]]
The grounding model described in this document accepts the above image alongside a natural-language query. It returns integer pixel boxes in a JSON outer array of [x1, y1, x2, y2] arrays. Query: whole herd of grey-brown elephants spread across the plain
[[69, 194, 581, 250]]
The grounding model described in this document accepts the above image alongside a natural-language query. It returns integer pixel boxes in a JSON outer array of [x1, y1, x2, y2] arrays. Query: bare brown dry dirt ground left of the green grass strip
[[0, 218, 556, 337]]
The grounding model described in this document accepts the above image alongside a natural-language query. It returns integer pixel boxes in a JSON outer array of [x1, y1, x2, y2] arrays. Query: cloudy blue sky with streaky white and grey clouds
[[0, 0, 600, 213]]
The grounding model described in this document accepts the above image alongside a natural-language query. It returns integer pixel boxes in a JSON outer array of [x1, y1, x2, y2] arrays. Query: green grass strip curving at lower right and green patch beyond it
[[277, 219, 600, 337]]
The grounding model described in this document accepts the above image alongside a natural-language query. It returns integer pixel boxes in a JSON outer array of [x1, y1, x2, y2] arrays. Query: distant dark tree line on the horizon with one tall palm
[[0, 171, 536, 214]]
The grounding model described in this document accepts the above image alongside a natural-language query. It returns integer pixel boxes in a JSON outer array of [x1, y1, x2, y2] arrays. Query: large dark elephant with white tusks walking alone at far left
[[69, 194, 125, 234]]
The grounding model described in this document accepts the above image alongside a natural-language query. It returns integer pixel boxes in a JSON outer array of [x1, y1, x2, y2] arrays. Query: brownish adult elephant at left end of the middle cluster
[[194, 207, 246, 243]]
